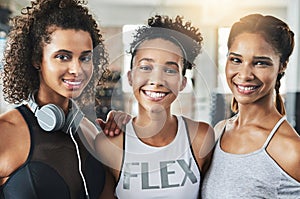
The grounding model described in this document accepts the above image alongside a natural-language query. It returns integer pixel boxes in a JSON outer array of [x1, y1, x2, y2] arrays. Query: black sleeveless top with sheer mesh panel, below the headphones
[[0, 105, 105, 199]]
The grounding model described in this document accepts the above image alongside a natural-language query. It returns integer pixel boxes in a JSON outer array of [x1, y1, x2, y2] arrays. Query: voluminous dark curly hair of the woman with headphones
[[2, 0, 108, 104]]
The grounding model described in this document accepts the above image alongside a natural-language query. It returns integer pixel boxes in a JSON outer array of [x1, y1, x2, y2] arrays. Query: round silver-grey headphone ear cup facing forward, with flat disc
[[35, 104, 65, 132]]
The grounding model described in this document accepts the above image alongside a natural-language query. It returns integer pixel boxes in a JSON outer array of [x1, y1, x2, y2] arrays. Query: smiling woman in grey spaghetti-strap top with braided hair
[[202, 14, 300, 199]]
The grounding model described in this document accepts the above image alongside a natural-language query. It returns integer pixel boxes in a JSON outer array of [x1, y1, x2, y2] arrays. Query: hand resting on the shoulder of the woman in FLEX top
[[96, 110, 131, 137]]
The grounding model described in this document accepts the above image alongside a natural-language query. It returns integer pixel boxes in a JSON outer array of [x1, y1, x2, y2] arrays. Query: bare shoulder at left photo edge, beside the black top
[[0, 109, 30, 181]]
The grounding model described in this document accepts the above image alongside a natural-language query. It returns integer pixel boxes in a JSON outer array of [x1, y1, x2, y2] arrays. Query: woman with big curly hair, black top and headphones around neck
[[0, 0, 108, 199]]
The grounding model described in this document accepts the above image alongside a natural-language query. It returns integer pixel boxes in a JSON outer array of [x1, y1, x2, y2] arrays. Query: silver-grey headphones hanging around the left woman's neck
[[28, 93, 84, 133]]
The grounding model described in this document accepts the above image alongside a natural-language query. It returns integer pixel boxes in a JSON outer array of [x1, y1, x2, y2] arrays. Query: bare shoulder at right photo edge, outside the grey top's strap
[[268, 121, 300, 182]]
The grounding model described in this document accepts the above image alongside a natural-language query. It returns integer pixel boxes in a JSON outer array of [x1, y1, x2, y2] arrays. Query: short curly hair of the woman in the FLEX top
[[129, 15, 203, 75]]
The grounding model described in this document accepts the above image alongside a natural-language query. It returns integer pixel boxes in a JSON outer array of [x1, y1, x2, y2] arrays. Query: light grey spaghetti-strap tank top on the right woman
[[201, 117, 300, 199]]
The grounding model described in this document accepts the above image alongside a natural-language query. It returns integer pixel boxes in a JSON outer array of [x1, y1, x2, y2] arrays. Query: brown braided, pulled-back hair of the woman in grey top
[[227, 14, 295, 115]]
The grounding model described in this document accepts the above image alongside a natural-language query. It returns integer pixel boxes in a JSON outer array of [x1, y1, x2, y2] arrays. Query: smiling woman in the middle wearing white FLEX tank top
[[95, 15, 214, 199]]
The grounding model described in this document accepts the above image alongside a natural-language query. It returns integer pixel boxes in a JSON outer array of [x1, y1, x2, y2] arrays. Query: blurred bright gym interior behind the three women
[[0, 0, 300, 132]]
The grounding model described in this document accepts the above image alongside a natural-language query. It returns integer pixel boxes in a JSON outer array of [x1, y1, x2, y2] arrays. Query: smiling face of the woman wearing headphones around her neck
[[36, 27, 93, 98]]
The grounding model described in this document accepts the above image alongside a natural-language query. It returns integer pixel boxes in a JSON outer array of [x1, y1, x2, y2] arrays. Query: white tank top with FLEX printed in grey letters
[[115, 116, 200, 199]]
